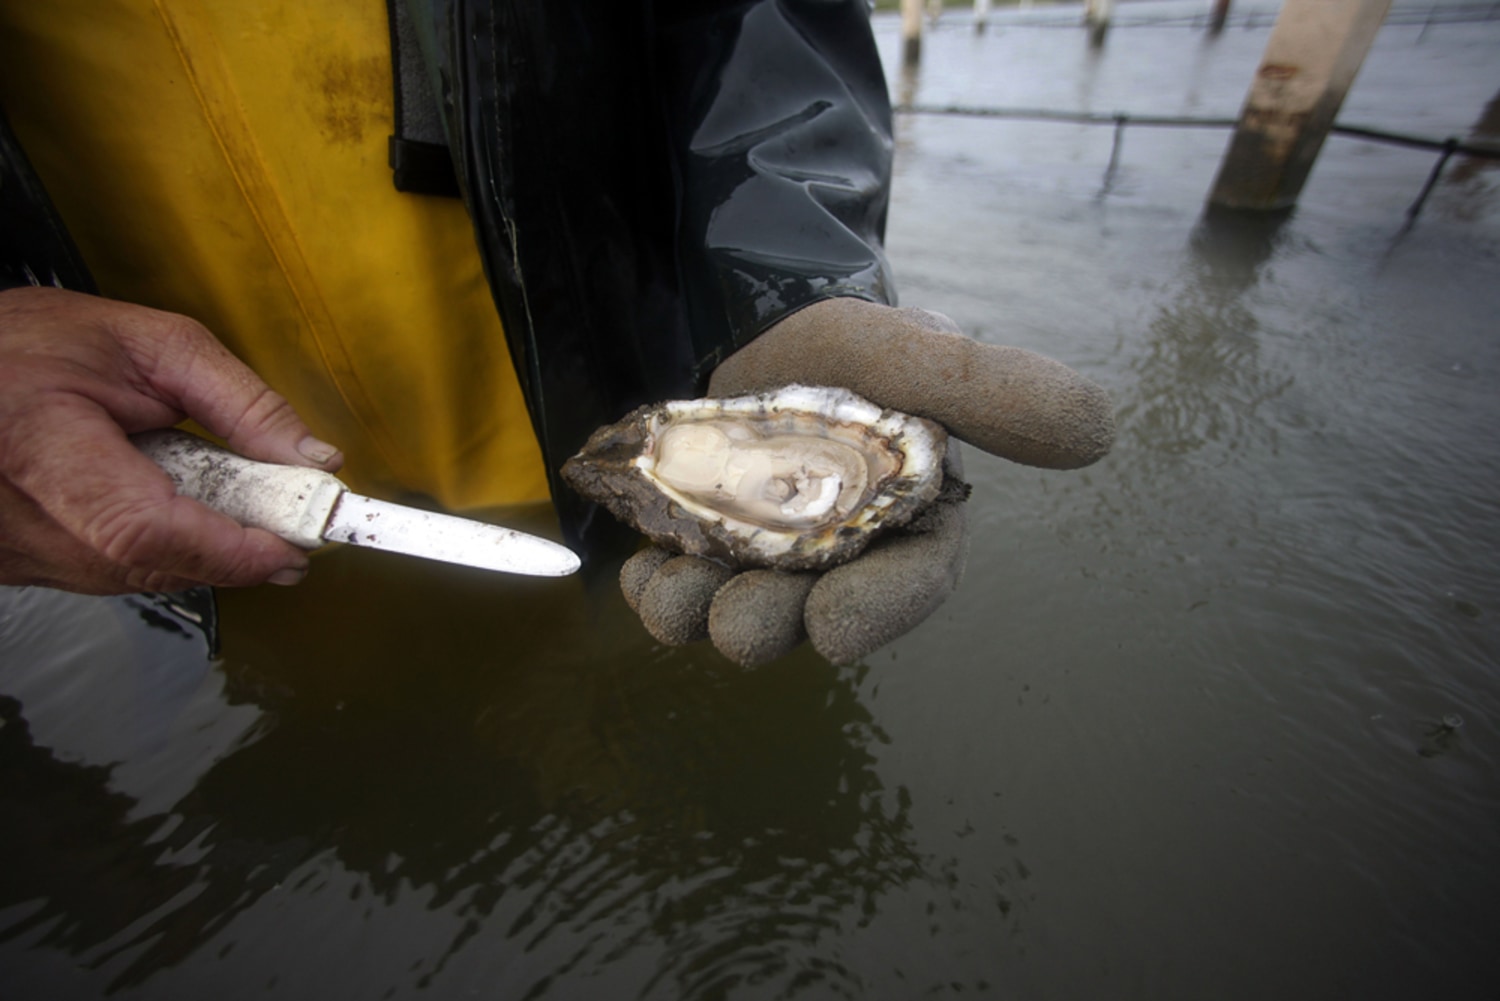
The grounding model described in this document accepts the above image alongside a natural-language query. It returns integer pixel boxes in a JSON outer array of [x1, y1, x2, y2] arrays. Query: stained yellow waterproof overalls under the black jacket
[[0, 0, 548, 509]]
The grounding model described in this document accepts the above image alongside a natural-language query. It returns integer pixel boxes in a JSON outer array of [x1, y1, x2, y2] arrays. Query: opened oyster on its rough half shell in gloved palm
[[563, 386, 948, 570]]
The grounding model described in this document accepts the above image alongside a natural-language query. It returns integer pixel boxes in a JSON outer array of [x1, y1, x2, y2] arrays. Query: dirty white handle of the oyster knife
[[131, 431, 348, 549]]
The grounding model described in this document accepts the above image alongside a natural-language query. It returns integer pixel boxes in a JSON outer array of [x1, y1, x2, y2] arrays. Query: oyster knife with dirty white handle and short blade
[[131, 431, 579, 576]]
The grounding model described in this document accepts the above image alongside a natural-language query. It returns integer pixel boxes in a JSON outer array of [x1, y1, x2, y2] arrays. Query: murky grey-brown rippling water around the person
[[0, 5, 1500, 999]]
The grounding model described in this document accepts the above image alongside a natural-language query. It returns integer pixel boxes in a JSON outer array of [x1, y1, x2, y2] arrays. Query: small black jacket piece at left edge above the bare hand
[[0, 111, 99, 294]]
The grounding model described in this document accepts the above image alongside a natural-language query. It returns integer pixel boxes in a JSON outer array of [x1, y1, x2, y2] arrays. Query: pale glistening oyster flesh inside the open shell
[[653, 420, 900, 530]]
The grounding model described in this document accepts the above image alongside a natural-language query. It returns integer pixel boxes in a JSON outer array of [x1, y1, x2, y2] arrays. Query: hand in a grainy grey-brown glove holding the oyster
[[620, 299, 1115, 666]]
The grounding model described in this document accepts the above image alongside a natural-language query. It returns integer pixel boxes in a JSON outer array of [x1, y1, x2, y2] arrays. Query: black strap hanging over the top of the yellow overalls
[[386, 0, 459, 198]]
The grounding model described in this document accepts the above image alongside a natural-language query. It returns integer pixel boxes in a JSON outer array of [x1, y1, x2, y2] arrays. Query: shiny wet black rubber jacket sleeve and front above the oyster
[[407, 0, 894, 557]]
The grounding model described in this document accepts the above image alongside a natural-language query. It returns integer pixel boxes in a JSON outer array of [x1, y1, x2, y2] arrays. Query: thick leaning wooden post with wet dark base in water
[[1209, 0, 1391, 212]]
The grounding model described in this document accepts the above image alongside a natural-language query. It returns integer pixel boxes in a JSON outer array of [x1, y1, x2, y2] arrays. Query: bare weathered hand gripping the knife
[[0, 288, 342, 594]]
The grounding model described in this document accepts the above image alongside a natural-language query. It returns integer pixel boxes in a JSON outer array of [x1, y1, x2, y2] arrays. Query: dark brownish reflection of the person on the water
[[0, 552, 948, 996]]
